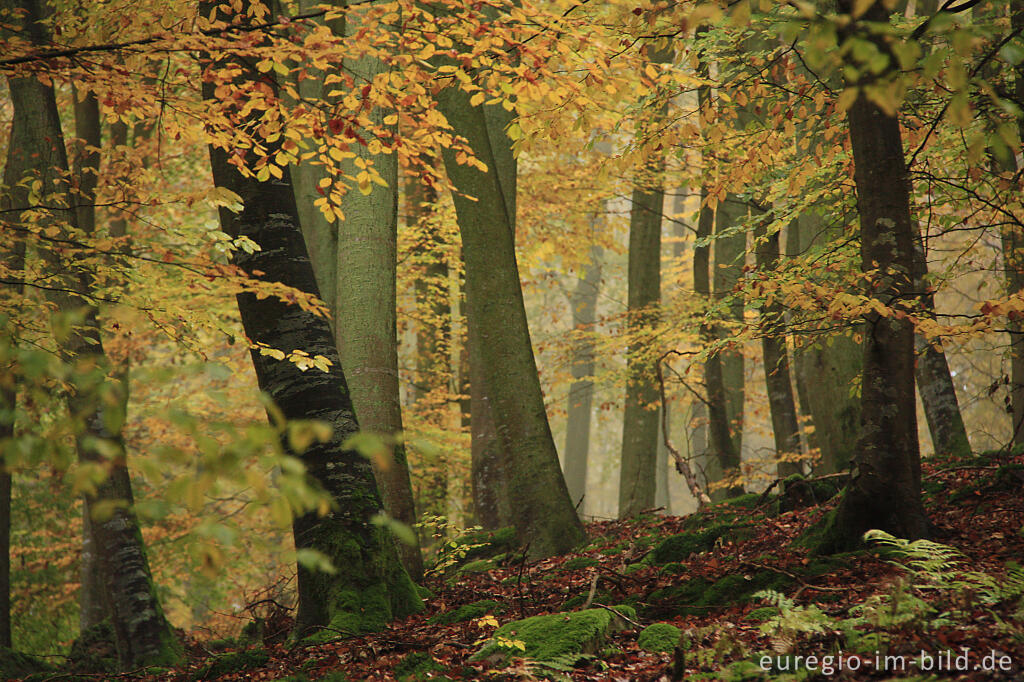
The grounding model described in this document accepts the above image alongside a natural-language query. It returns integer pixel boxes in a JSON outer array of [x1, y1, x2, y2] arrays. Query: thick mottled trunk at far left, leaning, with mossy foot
[[0, 0, 178, 668]]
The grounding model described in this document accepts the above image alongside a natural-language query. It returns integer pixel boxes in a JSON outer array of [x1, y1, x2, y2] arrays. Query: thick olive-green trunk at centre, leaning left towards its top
[[438, 79, 585, 557]]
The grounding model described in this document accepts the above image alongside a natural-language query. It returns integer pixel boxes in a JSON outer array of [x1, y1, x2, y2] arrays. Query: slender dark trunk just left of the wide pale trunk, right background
[[757, 225, 804, 478]]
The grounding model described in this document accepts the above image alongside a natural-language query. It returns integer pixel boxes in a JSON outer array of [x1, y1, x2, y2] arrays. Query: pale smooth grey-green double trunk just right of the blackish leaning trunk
[[284, 1, 423, 580]]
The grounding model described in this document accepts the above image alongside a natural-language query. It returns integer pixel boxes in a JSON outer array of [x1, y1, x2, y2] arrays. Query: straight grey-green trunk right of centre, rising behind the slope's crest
[[618, 35, 675, 518]]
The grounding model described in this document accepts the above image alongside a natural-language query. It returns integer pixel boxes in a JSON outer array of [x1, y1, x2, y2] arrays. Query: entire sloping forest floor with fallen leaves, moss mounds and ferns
[[14, 454, 1024, 682]]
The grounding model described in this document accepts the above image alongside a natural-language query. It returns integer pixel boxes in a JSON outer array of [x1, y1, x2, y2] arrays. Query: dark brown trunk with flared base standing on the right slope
[[822, 0, 929, 550]]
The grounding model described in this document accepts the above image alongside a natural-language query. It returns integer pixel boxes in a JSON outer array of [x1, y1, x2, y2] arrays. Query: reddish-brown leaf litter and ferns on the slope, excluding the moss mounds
[[16, 454, 1024, 682]]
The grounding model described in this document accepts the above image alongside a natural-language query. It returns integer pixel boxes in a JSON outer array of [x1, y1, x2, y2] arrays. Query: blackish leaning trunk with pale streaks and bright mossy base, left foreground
[[202, 3, 423, 635]]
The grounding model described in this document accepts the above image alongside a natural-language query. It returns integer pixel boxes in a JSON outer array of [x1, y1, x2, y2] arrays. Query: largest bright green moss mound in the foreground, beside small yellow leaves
[[470, 605, 636, 660]]
